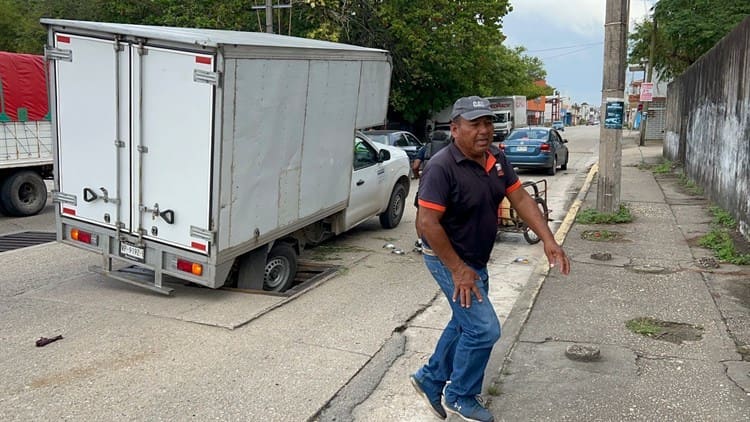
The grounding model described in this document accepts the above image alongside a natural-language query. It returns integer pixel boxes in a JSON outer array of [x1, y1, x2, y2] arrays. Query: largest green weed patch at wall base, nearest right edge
[[698, 206, 750, 265]]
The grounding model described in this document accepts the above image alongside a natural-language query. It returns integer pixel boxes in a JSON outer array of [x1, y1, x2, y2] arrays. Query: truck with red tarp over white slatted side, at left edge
[[0, 51, 53, 217]]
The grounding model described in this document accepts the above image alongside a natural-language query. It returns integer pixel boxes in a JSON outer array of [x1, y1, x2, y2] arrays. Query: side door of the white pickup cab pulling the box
[[345, 136, 385, 230]]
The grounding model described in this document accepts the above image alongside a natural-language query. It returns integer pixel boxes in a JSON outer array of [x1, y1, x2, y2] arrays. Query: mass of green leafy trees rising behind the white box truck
[[0, 0, 551, 122]]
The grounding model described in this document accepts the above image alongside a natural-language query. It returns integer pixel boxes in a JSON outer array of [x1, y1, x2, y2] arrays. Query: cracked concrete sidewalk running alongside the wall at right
[[484, 133, 750, 421]]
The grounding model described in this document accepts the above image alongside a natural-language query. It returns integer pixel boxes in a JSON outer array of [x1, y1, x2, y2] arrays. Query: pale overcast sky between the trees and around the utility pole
[[503, 0, 655, 105]]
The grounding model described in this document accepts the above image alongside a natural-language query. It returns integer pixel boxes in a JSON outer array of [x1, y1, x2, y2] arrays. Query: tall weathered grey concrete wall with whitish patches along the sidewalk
[[664, 17, 750, 238]]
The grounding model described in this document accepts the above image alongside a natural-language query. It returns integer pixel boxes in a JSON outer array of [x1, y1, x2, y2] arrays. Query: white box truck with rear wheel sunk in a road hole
[[41, 19, 409, 294]]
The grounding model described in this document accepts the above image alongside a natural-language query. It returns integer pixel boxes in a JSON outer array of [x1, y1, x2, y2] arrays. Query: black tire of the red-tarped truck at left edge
[[0, 170, 47, 217]]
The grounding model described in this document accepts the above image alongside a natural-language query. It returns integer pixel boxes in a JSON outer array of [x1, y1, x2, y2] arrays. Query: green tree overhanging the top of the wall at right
[[629, 0, 750, 79]]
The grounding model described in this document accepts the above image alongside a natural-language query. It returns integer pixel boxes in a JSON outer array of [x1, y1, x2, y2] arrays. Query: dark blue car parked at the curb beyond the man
[[500, 127, 569, 176]]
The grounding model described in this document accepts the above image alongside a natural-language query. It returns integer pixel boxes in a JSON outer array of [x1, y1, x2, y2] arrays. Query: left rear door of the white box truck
[[51, 33, 130, 228]]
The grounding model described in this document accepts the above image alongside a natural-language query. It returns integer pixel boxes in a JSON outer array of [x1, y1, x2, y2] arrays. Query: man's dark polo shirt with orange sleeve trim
[[418, 143, 521, 268]]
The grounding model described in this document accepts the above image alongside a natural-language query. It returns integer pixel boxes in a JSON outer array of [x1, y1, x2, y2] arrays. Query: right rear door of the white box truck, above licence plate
[[132, 45, 217, 254]]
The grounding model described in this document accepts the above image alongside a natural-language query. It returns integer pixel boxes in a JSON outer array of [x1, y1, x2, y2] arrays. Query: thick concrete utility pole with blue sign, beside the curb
[[596, 0, 630, 213]]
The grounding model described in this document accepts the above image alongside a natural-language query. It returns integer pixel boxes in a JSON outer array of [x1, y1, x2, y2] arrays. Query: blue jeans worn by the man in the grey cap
[[415, 255, 500, 401]]
